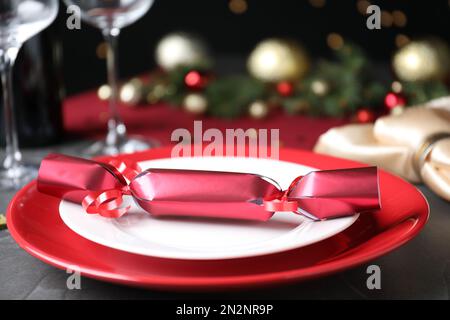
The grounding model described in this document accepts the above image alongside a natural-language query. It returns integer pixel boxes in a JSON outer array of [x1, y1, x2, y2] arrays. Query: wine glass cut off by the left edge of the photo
[[0, 0, 58, 190]]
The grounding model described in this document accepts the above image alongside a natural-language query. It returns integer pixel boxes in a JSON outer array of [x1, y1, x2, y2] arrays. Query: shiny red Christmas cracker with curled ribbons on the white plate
[[37, 154, 380, 221]]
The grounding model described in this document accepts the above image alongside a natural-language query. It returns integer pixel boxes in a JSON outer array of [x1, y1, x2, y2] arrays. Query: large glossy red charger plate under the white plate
[[7, 148, 429, 290]]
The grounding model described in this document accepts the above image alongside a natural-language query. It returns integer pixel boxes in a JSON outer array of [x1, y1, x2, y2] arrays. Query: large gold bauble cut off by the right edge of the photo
[[392, 38, 450, 81]]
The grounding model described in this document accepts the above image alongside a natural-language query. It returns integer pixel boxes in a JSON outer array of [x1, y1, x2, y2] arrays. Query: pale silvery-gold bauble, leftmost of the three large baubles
[[155, 32, 211, 70]]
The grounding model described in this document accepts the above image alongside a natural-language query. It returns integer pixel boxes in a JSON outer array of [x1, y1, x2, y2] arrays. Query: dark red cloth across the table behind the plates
[[64, 91, 347, 149]]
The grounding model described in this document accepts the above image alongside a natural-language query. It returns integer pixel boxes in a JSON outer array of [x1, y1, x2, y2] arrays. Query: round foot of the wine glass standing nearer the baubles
[[84, 137, 160, 157]]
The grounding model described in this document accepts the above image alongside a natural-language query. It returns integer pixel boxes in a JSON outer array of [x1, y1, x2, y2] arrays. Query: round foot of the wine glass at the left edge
[[0, 165, 38, 191]]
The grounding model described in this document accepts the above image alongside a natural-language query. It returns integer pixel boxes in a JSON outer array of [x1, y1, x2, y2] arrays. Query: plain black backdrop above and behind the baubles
[[55, 0, 450, 94]]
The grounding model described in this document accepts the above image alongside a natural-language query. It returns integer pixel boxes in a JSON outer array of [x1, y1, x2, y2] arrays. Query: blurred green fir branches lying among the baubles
[[146, 44, 448, 118]]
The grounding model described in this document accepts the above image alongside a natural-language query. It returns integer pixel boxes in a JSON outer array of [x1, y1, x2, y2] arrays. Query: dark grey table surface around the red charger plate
[[0, 144, 450, 300]]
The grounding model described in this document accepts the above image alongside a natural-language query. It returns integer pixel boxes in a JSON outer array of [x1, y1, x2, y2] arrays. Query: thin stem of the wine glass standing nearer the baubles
[[103, 28, 126, 148]]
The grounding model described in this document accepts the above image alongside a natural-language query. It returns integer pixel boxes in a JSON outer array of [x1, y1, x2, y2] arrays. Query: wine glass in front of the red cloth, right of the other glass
[[64, 0, 156, 156]]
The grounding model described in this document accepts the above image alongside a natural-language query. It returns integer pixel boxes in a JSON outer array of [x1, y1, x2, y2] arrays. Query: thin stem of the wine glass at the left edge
[[0, 46, 22, 170]]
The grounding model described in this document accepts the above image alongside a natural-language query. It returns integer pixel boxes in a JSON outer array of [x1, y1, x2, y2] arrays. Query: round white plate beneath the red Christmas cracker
[[59, 157, 358, 260]]
